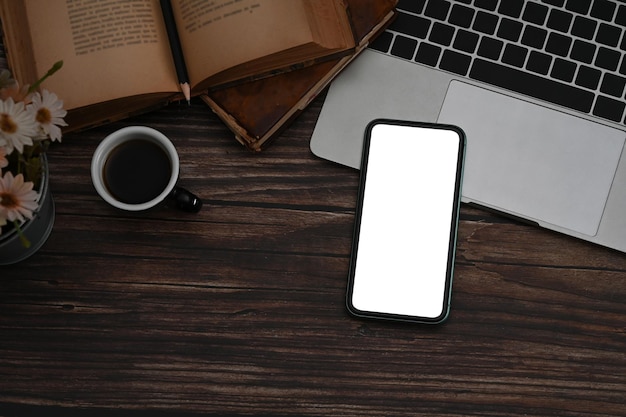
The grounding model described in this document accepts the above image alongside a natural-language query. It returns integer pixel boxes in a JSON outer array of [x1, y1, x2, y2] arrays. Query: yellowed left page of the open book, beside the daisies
[[23, 0, 178, 109]]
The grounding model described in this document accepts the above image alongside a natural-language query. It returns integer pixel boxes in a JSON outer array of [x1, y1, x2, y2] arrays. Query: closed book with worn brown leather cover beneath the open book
[[201, 0, 397, 151]]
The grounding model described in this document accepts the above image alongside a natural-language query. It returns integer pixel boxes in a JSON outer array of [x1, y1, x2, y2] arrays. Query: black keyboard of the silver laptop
[[370, 0, 626, 124]]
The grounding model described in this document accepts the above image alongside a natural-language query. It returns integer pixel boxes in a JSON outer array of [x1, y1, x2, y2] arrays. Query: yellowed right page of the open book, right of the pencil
[[172, 0, 313, 84]]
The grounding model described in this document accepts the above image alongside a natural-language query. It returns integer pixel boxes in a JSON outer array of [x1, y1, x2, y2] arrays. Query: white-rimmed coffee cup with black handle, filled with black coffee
[[91, 126, 202, 212]]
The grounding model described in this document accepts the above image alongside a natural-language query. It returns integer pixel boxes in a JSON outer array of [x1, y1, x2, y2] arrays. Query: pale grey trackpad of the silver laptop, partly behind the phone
[[438, 81, 625, 236]]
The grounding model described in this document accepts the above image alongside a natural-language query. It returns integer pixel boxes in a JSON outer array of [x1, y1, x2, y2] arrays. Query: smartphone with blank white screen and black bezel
[[346, 119, 466, 324]]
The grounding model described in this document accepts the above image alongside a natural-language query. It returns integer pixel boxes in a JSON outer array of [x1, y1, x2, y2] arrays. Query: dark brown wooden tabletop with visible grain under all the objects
[[0, 98, 626, 416]]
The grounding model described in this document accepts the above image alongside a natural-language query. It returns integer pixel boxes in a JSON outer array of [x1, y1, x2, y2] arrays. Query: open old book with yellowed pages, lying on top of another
[[0, 0, 355, 129]]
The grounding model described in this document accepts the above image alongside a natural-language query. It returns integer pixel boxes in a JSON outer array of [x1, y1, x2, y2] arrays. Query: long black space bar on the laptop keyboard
[[469, 58, 593, 113]]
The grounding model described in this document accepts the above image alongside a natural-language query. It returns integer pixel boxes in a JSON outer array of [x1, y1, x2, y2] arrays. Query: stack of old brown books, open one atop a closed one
[[0, 0, 397, 151]]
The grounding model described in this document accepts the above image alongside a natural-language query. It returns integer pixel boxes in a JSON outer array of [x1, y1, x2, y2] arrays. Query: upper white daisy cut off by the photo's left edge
[[0, 98, 38, 154]]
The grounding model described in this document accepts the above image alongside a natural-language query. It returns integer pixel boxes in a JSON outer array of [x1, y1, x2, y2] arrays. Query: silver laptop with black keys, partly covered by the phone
[[310, 0, 626, 252]]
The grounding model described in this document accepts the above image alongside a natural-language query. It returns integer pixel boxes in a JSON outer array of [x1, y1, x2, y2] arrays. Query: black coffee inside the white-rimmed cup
[[103, 139, 172, 204]]
